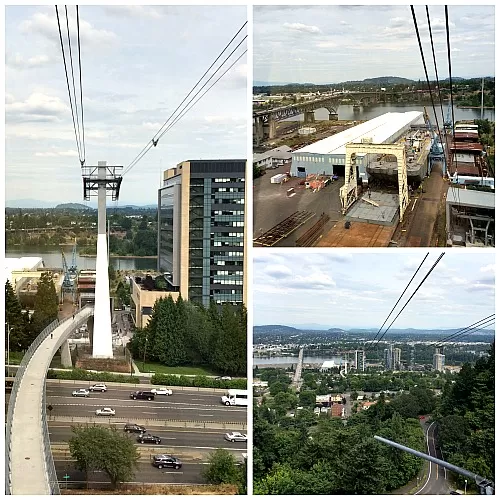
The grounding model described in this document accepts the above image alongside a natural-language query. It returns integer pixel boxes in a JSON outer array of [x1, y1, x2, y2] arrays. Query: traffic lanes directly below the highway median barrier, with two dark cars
[[49, 422, 246, 451]]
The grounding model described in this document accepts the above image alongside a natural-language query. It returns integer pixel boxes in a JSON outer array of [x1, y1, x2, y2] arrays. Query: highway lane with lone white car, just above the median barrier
[[47, 396, 247, 423]]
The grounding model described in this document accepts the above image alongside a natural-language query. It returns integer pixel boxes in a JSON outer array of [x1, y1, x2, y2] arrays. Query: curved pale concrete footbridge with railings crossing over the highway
[[5, 306, 94, 495]]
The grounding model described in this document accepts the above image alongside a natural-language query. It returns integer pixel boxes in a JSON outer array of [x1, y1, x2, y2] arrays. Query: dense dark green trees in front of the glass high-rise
[[129, 295, 247, 376]]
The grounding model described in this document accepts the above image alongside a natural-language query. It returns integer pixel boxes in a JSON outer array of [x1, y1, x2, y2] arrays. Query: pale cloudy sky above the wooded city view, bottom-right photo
[[253, 249, 495, 329]]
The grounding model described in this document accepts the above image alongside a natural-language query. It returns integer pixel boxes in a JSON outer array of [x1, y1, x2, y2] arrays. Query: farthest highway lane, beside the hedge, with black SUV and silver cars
[[46, 381, 224, 404]]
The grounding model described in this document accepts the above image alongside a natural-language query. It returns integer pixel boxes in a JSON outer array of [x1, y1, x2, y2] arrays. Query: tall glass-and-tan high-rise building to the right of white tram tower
[[158, 160, 246, 306]]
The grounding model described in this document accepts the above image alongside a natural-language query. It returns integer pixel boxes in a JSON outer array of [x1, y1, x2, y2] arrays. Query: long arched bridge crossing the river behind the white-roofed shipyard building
[[253, 90, 428, 146]]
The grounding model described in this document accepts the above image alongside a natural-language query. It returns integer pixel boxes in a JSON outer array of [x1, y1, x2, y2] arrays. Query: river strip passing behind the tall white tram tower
[[5, 245, 156, 271]]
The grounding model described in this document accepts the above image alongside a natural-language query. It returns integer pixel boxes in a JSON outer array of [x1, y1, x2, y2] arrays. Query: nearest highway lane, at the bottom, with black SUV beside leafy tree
[[54, 460, 206, 487]]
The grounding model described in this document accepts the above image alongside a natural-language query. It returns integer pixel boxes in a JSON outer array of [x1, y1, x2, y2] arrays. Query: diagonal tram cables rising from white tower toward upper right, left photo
[[123, 21, 248, 175]]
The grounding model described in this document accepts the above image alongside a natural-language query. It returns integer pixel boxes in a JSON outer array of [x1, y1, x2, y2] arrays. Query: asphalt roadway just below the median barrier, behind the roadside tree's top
[[49, 422, 246, 455]]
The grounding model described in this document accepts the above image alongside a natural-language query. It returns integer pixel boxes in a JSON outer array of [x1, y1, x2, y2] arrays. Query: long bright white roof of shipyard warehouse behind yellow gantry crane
[[293, 111, 424, 155]]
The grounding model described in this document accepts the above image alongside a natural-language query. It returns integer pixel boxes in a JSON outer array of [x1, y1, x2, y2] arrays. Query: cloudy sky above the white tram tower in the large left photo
[[5, 5, 247, 204]]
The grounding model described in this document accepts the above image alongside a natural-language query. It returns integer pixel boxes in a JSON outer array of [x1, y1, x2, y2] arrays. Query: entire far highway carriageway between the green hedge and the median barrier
[[47, 382, 247, 423]]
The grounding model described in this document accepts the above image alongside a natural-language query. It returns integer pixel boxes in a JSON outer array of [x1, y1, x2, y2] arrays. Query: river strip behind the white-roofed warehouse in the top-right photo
[[284, 103, 495, 126]]
